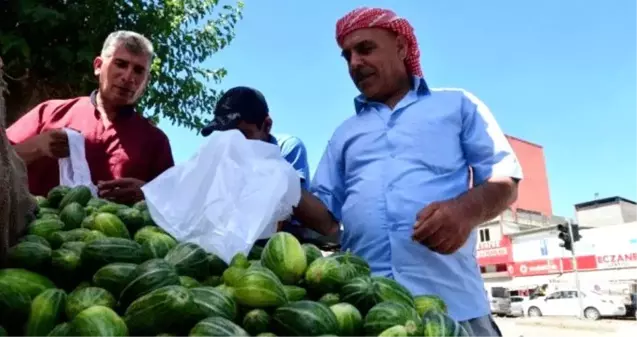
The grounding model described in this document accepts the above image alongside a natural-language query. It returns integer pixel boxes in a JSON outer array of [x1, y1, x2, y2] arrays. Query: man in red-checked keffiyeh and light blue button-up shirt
[[311, 8, 522, 337]]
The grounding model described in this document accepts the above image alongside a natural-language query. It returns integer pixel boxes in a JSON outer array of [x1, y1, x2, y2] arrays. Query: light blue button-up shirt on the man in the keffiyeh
[[311, 78, 522, 321]]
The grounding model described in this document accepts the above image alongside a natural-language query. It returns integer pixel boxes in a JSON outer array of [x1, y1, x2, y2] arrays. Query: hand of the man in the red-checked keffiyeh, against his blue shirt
[[413, 200, 474, 254]]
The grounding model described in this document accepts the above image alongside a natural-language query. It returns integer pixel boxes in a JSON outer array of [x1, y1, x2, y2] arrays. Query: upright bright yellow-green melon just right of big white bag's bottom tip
[[261, 232, 307, 285]]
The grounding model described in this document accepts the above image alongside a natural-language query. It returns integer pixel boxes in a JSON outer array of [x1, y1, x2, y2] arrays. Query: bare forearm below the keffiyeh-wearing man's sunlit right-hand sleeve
[[456, 178, 518, 226]]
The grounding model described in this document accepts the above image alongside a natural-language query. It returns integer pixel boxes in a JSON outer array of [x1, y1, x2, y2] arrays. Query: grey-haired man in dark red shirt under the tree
[[7, 31, 174, 203]]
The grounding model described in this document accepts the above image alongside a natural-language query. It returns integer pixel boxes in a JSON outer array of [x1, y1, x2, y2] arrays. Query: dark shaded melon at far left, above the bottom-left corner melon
[[7, 241, 52, 272]]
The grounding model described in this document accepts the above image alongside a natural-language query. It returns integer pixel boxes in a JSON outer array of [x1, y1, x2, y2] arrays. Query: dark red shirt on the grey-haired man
[[7, 92, 174, 196]]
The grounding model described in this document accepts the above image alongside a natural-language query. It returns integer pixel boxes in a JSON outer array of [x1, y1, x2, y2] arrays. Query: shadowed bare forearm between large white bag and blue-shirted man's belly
[[294, 190, 338, 235]]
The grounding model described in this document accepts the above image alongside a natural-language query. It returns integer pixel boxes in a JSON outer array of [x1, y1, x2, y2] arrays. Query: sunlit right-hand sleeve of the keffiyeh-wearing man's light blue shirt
[[461, 92, 522, 186]]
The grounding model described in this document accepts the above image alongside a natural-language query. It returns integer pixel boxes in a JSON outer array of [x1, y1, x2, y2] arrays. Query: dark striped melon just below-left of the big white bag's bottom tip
[[164, 242, 208, 280]]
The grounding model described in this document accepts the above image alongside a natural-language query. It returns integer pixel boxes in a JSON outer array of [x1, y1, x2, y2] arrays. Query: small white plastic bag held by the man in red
[[58, 128, 97, 196]]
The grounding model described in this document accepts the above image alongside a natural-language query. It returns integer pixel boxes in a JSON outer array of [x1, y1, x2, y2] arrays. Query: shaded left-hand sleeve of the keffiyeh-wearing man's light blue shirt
[[310, 142, 345, 221]]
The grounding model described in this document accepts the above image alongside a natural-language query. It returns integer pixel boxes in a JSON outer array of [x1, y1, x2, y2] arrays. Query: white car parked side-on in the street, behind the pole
[[522, 290, 626, 320]]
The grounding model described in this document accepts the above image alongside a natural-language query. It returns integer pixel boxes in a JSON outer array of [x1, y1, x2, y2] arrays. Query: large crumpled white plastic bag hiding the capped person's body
[[142, 130, 301, 263]]
